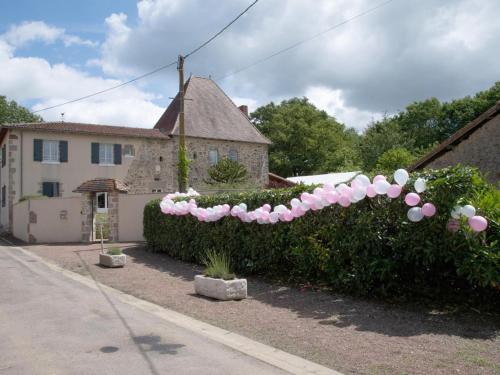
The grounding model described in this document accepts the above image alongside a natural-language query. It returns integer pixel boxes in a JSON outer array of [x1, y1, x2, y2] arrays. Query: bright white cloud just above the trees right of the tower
[[306, 86, 383, 132]]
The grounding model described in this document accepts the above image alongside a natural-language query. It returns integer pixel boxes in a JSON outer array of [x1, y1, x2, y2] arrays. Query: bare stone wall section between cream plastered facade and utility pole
[[124, 139, 177, 194]]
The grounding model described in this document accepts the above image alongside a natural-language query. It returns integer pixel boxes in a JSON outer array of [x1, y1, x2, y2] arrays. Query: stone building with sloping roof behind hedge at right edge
[[409, 101, 500, 183]]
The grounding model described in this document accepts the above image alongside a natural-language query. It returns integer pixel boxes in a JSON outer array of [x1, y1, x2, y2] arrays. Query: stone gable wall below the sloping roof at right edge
[[425, 115, 500, 183]]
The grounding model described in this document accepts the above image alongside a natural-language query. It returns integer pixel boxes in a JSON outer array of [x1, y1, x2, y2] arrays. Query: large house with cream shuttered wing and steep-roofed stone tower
[[0, 77, 270, 230]]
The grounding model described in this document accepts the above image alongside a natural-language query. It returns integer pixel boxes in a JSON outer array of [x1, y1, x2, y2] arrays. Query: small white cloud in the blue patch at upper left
[[0, 21, 97, 48]]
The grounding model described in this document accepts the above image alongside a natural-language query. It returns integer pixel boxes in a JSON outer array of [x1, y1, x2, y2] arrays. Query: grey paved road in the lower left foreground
[[0, 246, 285, 375]]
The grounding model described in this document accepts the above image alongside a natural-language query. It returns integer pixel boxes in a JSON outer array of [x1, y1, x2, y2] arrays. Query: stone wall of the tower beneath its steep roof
[[172, 137, 269, 189]]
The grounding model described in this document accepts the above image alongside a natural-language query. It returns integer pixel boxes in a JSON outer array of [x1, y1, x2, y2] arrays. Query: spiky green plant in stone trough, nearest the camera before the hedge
[[194, 250, 247, 301]]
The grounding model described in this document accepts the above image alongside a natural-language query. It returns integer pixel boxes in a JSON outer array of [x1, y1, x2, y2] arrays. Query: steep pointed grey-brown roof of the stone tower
[[155, 76, 271, 144]]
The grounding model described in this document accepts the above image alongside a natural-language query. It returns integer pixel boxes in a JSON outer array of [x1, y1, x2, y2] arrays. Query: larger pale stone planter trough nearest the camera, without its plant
[[194, 275, 247, 301]]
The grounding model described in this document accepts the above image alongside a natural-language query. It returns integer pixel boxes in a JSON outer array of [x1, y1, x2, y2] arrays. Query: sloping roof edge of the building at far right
[[408, 101, 500, 171]]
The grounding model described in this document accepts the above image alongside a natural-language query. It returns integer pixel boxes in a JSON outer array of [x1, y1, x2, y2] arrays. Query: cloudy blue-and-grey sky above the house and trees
[[0, 0, 500, 131]]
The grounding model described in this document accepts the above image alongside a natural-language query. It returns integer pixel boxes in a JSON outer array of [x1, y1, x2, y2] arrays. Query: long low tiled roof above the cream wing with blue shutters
[[1, 121, 168, 138]]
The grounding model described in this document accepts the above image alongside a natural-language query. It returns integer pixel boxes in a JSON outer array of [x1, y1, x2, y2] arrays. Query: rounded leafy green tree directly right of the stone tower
[[251, 98, 360, 177]]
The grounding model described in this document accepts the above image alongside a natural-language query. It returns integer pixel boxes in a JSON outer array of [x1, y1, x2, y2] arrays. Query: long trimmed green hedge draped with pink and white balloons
[[144, 167, 500, 297]]
